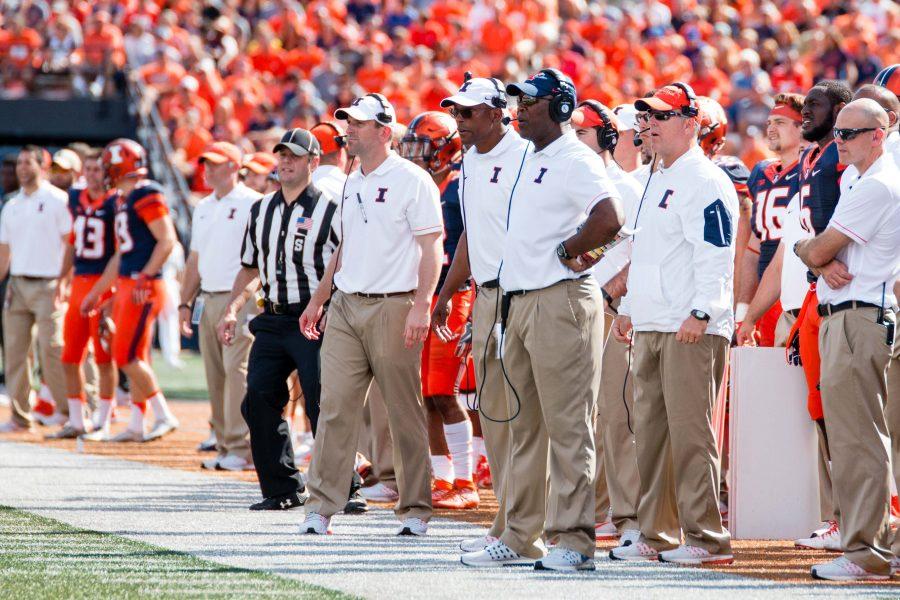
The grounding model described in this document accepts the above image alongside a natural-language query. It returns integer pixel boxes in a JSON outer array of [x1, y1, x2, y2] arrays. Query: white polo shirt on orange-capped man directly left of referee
[[191, 183, 262, 292]]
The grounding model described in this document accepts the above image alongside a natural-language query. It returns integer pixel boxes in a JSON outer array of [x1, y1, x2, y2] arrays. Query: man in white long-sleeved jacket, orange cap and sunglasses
[[610, 83, 738, 564]]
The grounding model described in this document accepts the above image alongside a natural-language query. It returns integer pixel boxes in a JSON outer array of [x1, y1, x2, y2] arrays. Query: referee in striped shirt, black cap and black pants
[[218, 129, 344, 510]]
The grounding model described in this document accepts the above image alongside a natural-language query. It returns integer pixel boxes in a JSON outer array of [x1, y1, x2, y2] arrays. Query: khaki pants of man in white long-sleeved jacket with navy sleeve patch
[[634, 331, 731, 554]]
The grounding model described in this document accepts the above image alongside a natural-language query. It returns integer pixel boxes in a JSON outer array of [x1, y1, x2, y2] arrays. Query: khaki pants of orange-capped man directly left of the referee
[[200, 292, 258, 460]]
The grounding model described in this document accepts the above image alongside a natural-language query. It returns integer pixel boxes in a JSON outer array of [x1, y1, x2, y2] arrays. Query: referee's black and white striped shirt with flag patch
[[241, 184, 340, 304]]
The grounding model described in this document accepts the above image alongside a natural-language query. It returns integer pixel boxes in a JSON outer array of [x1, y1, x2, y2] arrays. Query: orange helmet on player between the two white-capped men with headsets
[[400, 110, 462, 175]]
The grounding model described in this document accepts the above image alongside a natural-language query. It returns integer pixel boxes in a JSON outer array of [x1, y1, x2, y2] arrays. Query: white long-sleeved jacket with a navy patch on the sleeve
[[619, 146, 738, 339]]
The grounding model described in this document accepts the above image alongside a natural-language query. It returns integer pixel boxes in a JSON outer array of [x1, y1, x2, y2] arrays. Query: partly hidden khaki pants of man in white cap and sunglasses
[[472, 288, 512, 537]]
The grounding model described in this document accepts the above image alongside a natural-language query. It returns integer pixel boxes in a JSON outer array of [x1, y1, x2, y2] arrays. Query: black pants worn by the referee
[[241, 313, 362, 498]]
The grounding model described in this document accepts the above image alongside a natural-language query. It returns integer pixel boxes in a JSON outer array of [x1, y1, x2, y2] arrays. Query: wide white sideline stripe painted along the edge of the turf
[[0, 441, 894, 600]]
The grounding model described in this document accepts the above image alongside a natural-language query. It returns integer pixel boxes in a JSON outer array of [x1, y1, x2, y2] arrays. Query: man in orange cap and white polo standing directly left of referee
[[178, 142, 260, 471]]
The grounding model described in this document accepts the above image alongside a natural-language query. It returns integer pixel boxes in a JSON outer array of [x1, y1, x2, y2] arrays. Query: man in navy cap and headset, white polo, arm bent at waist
[[462, 69, 623, 571]]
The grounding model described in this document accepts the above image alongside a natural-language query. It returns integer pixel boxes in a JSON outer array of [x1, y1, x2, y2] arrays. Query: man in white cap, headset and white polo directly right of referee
[[300, 94, 444, 535]]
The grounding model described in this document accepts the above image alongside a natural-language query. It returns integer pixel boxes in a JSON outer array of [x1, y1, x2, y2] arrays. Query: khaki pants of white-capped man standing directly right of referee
[[306, 291, 432, 521]]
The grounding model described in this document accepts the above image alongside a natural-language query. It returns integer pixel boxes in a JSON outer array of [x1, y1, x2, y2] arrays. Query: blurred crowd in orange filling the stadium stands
[[0, 0, 900, 191]]
